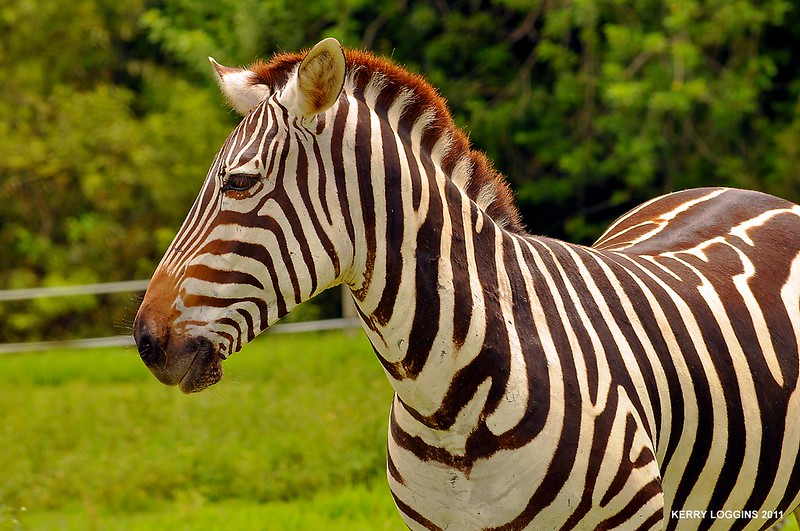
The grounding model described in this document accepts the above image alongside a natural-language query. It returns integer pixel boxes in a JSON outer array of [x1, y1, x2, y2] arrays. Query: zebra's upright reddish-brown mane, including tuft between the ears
[[249, 50, 525, 233]]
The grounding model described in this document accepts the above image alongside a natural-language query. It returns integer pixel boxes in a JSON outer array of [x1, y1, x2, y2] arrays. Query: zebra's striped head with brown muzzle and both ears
[[134, 39, 352, 392]]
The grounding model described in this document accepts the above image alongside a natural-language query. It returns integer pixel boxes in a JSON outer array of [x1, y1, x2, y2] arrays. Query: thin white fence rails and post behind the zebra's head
[[0, 280, 361, 354]]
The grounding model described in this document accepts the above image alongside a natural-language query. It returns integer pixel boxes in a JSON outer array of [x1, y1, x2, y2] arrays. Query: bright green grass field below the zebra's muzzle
[[0, 333, 405, 530]]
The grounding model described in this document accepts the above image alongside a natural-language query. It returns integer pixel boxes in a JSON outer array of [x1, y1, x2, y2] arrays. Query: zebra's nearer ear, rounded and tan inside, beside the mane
[[280, 38, 345, 118]]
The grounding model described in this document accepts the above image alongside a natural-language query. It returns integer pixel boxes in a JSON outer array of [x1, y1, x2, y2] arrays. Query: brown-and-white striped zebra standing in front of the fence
[[134, 38, 800, 530]]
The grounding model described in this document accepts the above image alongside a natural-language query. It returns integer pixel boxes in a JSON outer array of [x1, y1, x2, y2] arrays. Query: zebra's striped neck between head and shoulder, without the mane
[[333, 90, 536, 431]]
